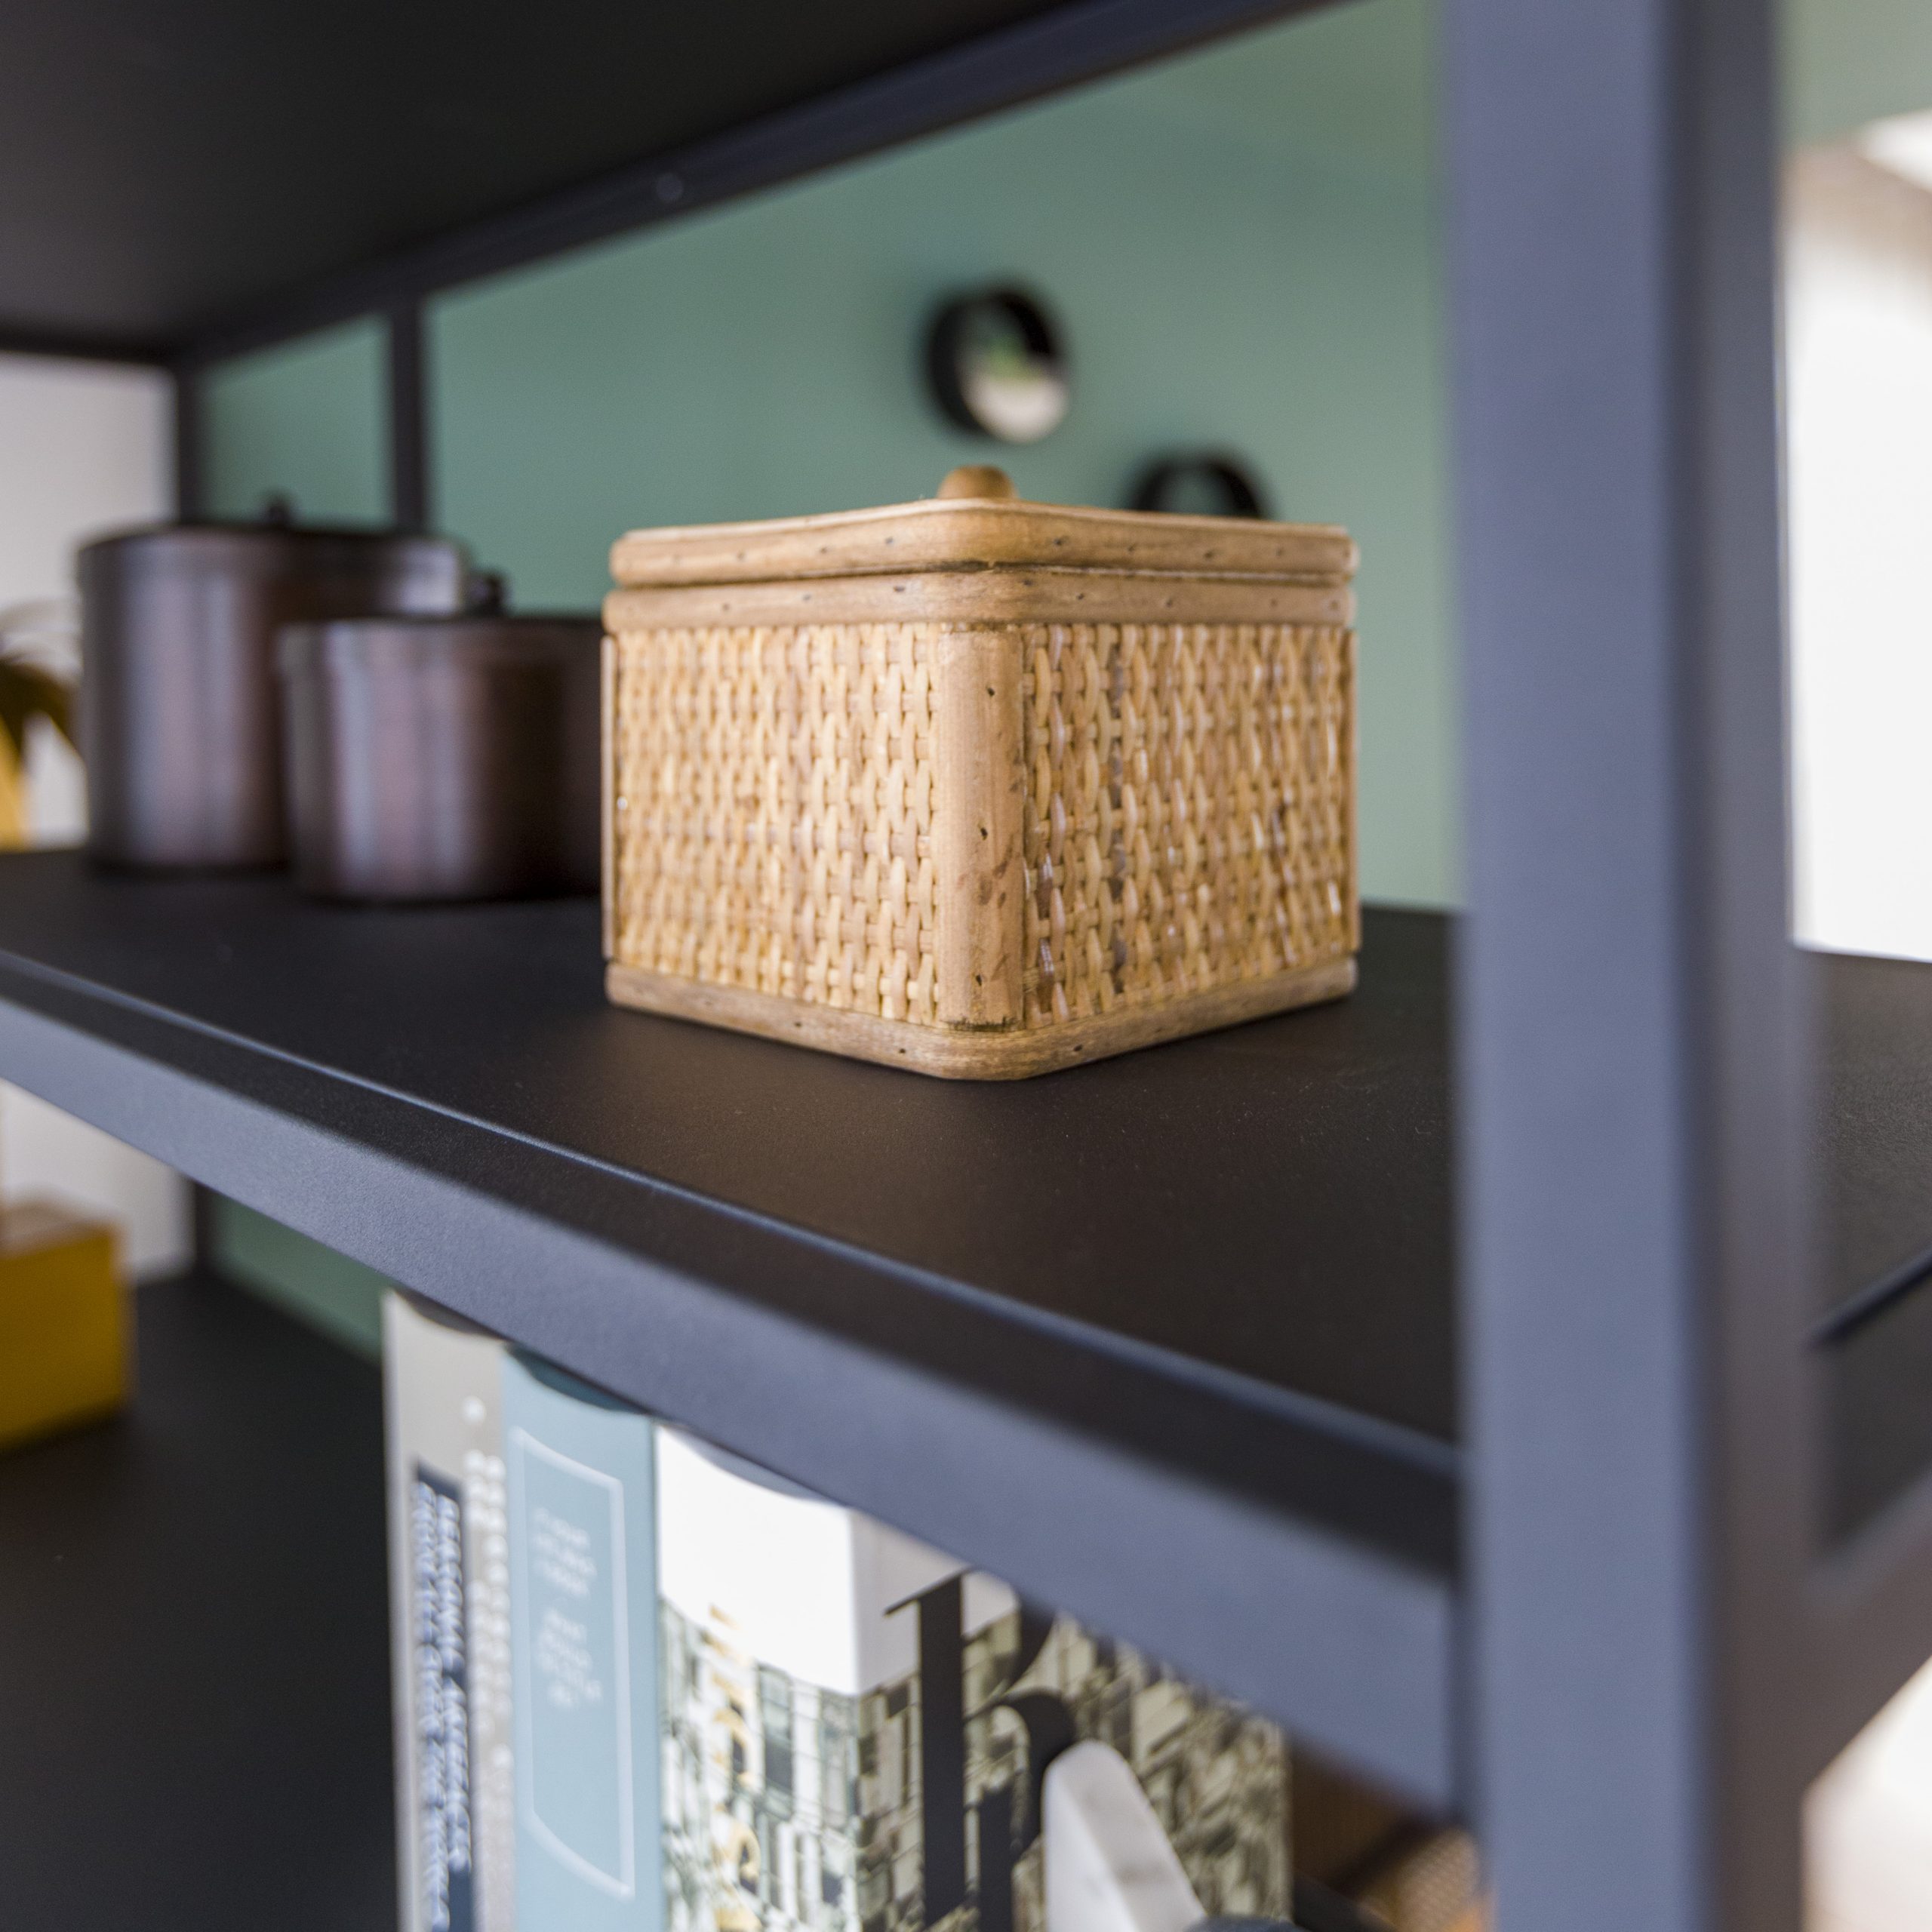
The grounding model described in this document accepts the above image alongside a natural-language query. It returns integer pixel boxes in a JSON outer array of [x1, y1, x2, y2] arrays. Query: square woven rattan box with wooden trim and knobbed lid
[[605, 469, 1360, 1080]]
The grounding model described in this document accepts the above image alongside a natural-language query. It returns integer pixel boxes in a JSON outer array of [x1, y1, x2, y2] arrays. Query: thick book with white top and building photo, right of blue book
[[657, 1429, 1291, 1932]]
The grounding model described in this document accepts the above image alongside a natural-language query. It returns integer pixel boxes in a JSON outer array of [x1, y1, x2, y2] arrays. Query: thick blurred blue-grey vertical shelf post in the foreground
[[1445, 0, 1810, 1932]]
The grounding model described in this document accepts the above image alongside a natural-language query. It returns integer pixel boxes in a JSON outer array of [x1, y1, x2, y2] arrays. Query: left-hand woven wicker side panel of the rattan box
[[613, 624, 937, 1026]]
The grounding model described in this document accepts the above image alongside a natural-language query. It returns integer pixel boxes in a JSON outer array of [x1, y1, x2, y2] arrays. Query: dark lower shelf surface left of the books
[[0, 1279, 396, 1932]]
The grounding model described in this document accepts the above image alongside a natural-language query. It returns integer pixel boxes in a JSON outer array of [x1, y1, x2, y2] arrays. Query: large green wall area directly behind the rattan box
[[431, 0, 1457, 904]]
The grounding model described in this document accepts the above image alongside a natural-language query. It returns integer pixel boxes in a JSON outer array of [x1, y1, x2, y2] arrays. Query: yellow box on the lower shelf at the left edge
[[0, 1201, 131, 1447]]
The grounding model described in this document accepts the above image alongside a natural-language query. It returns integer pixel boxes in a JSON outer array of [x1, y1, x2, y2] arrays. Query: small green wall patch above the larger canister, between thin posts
[[201, 321, 389, 524]]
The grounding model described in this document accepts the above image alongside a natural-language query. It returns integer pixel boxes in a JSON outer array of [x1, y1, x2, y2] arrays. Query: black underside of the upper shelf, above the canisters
[[0, 0, 1049, 344]]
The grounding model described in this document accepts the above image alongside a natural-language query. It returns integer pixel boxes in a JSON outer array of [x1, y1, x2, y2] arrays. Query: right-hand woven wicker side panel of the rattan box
[[1020, 624, 1356, 1026]]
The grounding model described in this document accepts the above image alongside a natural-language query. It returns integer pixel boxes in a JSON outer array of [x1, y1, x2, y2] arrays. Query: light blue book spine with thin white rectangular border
[[503, 1355, 663, 1932]]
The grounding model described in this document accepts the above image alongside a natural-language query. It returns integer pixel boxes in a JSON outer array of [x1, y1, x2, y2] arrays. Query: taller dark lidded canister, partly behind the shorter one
[[79, 514, 468, 869]]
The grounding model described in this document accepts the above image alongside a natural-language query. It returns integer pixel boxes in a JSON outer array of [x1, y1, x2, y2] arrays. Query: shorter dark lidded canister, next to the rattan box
[[280, 613, 603, 900]]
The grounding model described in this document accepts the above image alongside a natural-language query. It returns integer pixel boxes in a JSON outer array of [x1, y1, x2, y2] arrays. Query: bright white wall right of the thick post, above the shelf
[[1785, 149, 1932, 958]]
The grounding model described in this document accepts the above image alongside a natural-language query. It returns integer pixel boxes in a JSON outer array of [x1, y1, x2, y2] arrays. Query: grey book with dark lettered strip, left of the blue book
[[383, 1294, 516, 1932]]
